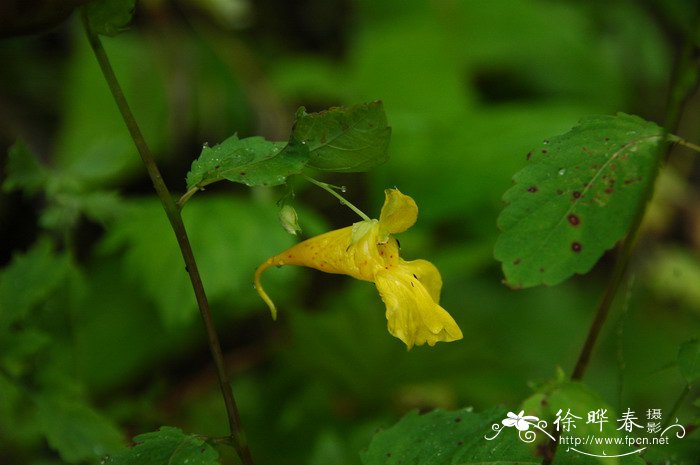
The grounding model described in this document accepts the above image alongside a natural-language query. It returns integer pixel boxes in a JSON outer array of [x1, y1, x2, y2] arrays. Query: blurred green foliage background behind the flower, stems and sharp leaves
[[0, 0, 700, 465]]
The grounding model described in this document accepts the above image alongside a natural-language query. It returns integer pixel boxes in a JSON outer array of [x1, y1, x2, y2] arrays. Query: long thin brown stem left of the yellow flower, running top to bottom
[[83, 10, 253, 465]]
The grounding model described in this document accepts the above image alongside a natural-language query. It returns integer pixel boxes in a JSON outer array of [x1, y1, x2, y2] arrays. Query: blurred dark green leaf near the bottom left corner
[[35, 393, 124, 463]]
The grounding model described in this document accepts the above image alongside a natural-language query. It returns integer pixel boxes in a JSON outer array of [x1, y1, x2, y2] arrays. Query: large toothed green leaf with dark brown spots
[[494, 114, 666, 288]]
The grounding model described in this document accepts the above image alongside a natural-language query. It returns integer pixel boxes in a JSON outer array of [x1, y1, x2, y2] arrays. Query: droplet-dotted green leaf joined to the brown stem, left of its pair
[[187, 134, 308, 190]]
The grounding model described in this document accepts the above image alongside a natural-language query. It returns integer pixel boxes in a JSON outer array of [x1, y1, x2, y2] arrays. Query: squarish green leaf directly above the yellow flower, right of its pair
[[292, 101, 391, 173]]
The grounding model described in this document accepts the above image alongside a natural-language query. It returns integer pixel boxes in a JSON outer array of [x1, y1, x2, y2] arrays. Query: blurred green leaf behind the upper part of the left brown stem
[[52, 31, 168, 189]]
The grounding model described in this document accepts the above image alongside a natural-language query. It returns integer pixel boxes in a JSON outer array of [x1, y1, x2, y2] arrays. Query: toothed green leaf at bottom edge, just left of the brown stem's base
[[104, 426, 219, 465]]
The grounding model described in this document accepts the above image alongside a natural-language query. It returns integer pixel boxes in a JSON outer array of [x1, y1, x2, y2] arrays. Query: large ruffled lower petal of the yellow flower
[[375, 263, 462, 349]]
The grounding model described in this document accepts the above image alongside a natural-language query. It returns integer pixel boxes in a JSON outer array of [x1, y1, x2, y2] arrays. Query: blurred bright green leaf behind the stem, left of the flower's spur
[[101, 195, 313, 326]]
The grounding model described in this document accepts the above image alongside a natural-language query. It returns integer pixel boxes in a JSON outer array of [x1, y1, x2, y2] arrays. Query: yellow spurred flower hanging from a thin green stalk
[[255, 189, 462, 349]]
